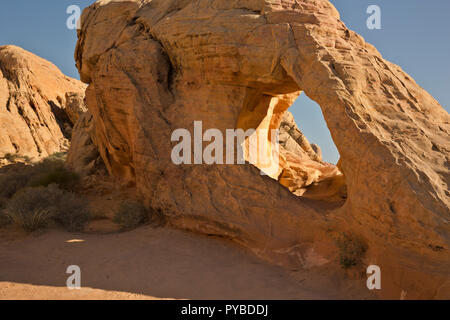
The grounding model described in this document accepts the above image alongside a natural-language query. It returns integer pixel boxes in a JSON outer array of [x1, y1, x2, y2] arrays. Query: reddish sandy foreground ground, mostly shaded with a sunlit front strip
[[0, 222, 370, 299]]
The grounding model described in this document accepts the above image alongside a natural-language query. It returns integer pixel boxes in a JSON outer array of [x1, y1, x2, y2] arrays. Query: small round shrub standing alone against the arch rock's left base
[[114, 201, 148, 230]]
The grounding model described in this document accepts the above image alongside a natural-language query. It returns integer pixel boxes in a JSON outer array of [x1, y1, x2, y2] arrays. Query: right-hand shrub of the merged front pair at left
[[54, 192, 91, 232]]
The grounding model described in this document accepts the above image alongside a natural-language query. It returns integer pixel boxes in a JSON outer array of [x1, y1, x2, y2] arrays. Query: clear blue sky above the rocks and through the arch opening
[[0, 0, 450, 163]]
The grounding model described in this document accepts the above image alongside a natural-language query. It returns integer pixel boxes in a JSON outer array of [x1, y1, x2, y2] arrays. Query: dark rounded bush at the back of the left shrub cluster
[[28, 157, 78, 189]]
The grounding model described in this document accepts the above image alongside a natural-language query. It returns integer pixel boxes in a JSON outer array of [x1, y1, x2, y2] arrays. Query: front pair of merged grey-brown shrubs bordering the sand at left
[[5, 184, 90, 232]]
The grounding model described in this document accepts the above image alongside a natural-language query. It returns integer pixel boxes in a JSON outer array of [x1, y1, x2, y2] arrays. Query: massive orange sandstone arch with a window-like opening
[[75, 0, 450, 298]]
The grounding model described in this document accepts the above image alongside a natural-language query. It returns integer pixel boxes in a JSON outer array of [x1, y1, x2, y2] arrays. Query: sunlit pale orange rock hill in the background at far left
[[0, 46, 86, 160]]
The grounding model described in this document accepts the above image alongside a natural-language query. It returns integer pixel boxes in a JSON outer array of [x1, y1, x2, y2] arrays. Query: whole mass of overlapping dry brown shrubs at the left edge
[[0, 153, 85, 232]]
